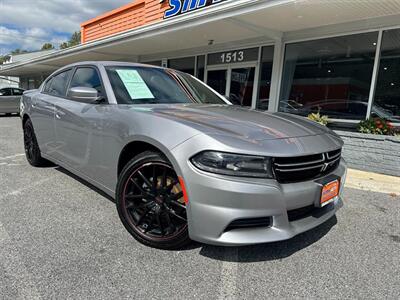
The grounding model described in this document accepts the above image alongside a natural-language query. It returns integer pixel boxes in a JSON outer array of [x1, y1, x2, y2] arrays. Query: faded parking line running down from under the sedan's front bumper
[[219, 247, 239, 299]]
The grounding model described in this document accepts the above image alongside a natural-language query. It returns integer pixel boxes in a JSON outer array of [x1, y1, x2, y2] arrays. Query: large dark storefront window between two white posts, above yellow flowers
[[279, 32, 378, 120]]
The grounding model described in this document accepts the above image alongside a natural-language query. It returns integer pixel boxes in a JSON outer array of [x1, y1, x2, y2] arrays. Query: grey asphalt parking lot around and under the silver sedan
[[0, 117, 400, 299]]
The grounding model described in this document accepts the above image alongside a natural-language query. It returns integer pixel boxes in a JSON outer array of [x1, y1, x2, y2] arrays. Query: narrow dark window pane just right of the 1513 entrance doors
[[257, 46, 274, 110]]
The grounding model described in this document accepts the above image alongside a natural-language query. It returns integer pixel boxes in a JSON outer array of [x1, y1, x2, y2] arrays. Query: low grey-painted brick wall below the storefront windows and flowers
[[336, 131, 400, 176]]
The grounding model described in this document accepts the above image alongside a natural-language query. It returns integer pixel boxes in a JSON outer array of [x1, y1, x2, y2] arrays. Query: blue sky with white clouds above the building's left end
[[0, 0, 133, 55]]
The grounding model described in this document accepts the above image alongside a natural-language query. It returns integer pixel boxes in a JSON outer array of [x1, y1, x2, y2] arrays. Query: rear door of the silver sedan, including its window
[[30, 69, 72, 158]]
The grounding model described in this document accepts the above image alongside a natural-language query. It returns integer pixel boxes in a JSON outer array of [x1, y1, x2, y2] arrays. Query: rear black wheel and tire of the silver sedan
[[24, 119, 48, 167]]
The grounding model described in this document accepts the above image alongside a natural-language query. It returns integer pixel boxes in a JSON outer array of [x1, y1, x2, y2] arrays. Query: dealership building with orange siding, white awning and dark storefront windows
[[0, 0, 400, 126]]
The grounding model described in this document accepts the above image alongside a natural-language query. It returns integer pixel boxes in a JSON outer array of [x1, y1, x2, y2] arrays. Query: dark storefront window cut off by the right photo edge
[[371, 29, 400, 123]]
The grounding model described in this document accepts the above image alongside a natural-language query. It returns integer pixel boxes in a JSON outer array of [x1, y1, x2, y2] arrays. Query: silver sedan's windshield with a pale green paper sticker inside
[[106, 66, 226, 104]]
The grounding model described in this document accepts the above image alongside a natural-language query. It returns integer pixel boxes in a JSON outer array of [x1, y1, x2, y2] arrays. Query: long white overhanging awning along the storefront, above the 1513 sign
[[0, 0, 400, 76]]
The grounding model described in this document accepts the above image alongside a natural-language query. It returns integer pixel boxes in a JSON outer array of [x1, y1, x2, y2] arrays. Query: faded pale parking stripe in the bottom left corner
[[0, 223, 41, 299]]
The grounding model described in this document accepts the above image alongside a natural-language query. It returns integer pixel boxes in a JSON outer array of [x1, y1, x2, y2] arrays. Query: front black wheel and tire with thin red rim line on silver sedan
[[116, 151, 190, 250]]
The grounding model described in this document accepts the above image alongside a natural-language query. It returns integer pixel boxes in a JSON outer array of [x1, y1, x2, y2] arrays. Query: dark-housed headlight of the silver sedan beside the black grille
[[190, 151, 273, 178]]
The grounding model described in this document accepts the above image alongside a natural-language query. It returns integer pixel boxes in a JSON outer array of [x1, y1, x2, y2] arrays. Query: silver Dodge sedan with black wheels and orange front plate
[[21, 62, 346, 249]]
